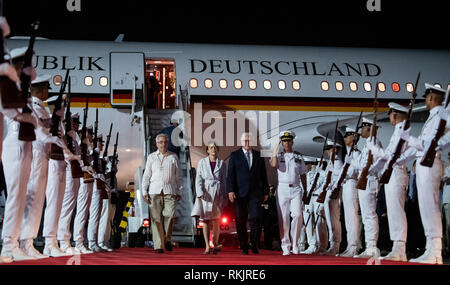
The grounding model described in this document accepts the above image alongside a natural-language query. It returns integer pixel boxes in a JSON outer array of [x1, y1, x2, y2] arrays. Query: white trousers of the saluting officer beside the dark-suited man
[[277, 183, 303, 251]]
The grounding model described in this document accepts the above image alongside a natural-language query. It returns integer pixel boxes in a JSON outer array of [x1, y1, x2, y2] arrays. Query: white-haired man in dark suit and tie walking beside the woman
[[227, 133, 269, 254]]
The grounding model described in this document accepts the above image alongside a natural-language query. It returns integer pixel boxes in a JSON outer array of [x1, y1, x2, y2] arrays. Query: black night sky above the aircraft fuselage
[[3, 0, 450, 49]]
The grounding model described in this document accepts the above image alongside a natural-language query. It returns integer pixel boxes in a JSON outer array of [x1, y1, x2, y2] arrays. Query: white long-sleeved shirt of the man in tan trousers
[[142, 150, 183, 195]]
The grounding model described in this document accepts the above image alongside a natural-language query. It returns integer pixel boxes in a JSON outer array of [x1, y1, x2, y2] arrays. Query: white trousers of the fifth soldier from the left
[[73, 179, 94, 245]]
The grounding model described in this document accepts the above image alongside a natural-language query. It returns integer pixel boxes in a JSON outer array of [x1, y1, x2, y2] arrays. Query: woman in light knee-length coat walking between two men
[[191, 142, 227, 254]]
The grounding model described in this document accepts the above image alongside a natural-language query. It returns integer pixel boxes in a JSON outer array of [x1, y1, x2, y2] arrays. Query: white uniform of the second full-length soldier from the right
[[373, 121, 409, 261]]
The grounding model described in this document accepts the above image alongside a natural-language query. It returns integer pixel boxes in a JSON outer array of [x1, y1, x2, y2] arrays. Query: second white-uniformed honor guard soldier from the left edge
[[20, 75, 63, 258]]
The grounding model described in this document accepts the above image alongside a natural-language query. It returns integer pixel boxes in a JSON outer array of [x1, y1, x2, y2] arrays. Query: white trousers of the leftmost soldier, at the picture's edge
[[2, 134, 33, 242]]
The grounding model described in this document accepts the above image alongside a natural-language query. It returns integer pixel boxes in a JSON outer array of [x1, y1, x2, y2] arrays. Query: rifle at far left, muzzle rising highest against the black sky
[[19, 21, 39, 141]]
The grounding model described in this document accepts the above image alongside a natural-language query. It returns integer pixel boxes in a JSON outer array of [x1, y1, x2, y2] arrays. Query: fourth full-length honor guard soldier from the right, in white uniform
[[339, 127, 360, 257]]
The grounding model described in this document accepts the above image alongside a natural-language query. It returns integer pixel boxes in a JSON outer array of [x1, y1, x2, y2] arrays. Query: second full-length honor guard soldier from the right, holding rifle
[[368, 102, 409, 261]]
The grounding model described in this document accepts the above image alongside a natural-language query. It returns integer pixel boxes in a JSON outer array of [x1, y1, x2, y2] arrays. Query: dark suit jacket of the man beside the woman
[[227, 148, 269, 201]]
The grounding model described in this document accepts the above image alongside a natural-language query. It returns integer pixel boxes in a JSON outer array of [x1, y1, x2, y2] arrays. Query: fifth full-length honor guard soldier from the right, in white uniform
[[322, 140, 343, 256]]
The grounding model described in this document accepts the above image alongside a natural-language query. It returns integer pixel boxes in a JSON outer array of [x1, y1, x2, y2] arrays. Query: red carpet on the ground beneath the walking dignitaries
[[0, 245, 428, 265]]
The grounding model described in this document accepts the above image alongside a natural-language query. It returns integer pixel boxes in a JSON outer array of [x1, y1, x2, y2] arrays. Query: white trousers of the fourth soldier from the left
[[58, 167, 80, 241]]
